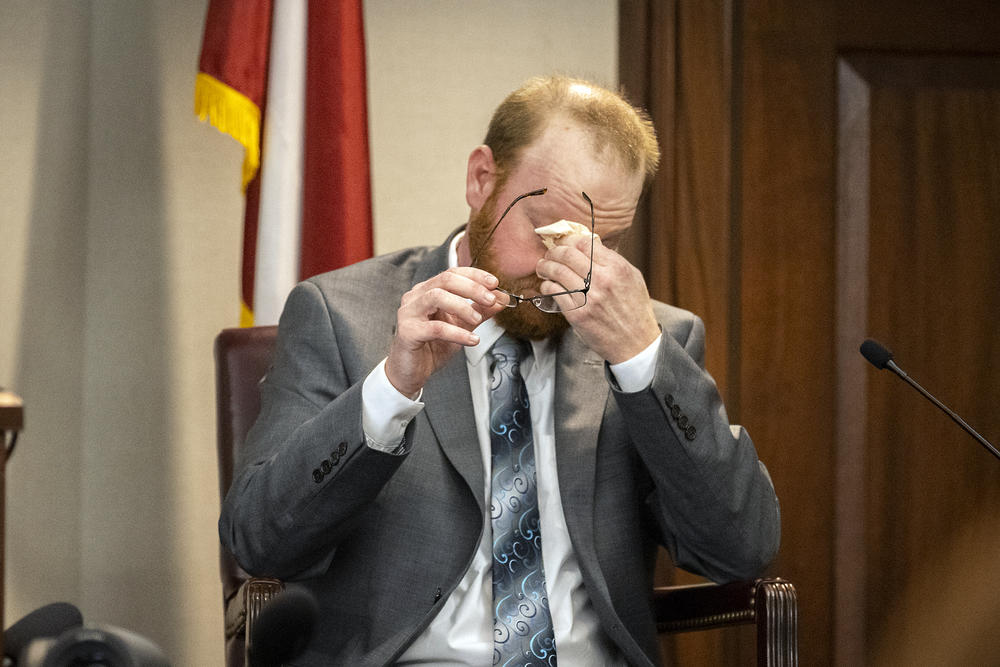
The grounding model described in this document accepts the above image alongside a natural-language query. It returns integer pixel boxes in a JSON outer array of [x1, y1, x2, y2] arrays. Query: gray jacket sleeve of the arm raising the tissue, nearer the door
[[608, 311, 781, 582]]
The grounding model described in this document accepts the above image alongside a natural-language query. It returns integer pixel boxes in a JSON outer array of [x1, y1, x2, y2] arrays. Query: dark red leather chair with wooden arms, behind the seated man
[[215, 326, 798, 667]]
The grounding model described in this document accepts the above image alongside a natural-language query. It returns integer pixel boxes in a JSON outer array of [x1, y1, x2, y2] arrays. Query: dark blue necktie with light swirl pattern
[[490, 335, 556, 667]]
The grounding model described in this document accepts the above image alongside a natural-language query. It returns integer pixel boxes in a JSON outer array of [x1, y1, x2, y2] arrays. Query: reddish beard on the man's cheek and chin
[[466, 200, 569, 340]]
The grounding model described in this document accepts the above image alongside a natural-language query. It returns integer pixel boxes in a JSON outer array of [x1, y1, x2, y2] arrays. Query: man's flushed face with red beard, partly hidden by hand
[[468, 118, 642, 340]]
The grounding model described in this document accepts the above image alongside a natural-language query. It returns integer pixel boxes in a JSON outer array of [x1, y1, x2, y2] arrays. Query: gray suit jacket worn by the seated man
[[219, 232, 780, 665]]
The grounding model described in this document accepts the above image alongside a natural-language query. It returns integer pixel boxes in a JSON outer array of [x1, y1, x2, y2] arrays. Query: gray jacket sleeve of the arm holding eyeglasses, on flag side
[[219, 282, 406, 579]]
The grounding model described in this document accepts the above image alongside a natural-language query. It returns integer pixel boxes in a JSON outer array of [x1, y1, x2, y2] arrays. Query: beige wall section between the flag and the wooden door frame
[[365, 0, 618, 252]]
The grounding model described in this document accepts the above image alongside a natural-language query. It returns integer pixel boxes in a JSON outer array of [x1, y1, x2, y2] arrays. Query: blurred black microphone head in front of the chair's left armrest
[[249, 588, 319, 667]]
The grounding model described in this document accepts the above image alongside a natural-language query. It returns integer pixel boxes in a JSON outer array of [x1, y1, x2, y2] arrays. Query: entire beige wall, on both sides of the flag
[[0, 0, 617, 665]]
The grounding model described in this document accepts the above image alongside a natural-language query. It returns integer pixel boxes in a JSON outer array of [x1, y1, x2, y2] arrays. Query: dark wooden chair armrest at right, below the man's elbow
[[653, 579, 798, 665]]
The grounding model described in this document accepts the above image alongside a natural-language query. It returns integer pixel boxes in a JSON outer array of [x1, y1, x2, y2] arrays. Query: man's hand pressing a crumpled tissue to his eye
[[535, 235, 660, 364]]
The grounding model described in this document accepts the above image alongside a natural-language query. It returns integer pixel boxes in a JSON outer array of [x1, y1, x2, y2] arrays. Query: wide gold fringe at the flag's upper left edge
[[194, 72, 260, 191]]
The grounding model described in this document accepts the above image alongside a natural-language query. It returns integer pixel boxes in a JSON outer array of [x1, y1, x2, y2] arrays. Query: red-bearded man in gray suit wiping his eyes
[[220, 77, 780, 667]]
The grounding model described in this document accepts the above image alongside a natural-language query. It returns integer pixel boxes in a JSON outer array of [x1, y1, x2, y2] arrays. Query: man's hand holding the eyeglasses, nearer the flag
[[385, 266, 507, 397]]
